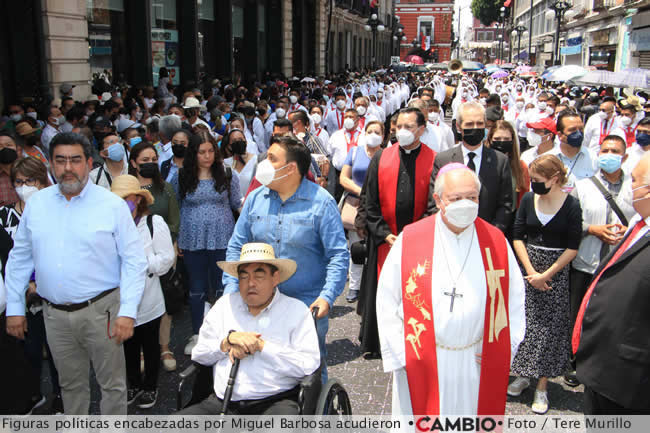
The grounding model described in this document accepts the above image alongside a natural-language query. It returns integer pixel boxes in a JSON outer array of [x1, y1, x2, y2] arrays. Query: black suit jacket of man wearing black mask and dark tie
[[427, 144, 514, 232]]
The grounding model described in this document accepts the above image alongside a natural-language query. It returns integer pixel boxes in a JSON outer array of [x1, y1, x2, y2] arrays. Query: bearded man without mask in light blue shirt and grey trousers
[[6, 133, 147, 415]]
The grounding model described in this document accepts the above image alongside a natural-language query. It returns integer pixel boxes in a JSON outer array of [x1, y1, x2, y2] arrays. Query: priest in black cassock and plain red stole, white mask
[[357, 108, 435, 357]]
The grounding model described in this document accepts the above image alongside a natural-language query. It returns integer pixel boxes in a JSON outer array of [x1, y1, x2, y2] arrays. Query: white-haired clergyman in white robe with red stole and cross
[[377, 163, 525, 416]]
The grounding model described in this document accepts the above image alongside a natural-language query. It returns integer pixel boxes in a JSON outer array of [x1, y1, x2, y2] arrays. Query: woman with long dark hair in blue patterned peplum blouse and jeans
[[171, 132, 241, 355]]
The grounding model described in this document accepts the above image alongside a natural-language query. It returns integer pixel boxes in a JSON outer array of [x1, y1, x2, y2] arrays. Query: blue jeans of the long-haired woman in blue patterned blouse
[[183, 250, 226, 335]]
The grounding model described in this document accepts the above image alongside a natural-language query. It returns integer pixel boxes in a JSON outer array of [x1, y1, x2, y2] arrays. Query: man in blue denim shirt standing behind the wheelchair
[[223, 136, 350, 383]]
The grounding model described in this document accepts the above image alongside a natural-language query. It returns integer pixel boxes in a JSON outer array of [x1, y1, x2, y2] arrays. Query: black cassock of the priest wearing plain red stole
[[357, 146, 421, 354]]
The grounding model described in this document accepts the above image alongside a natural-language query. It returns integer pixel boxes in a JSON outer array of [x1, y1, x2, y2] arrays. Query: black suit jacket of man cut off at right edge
[[576, 219, 650, 410]]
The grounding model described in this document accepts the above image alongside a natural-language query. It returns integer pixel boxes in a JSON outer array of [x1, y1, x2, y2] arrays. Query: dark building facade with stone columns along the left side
[[0, 0, 396, 106]]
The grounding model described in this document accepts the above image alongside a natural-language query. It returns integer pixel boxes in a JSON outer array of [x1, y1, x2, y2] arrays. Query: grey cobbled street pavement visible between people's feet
[[35, 286, 583, 415]]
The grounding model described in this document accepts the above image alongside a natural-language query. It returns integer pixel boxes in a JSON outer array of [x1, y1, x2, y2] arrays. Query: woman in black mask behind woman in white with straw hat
[[129, 142, 181, 371]]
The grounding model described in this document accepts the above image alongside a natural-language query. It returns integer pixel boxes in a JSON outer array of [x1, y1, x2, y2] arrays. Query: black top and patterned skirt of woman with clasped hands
[[511, 192, 582, 378]]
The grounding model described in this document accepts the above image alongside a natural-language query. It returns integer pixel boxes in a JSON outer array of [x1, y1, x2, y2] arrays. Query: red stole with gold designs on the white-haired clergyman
[[402, 216, 510, 415]]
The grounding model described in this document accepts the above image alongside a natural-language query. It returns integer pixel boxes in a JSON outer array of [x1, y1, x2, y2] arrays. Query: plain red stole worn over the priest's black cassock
[[377, 144, 436, 280]]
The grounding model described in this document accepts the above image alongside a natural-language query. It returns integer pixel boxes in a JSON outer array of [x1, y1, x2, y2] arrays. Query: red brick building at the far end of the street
[[395, 0, 454, 62]]
